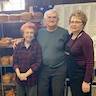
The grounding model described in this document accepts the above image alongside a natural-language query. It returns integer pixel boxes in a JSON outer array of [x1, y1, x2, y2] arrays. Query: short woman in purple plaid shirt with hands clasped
[[13, 22, 41, 96]]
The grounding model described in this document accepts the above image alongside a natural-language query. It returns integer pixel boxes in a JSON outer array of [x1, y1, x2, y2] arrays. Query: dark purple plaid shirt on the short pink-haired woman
[[13, 40, 42, 86]]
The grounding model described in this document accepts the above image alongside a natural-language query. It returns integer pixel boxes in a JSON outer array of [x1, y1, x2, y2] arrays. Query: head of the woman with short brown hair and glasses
[[69, 10, 87, 33]]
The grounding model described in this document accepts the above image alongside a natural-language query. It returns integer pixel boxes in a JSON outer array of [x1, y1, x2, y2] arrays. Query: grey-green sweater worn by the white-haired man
[[37, 27, 69, 68]]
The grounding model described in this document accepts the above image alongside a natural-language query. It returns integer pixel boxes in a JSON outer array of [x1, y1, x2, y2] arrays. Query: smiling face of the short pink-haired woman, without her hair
[[23, 28, 35, 42]]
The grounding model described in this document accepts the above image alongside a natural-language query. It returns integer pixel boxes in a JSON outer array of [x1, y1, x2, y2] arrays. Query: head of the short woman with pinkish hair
[[21, 22, 36, 42]]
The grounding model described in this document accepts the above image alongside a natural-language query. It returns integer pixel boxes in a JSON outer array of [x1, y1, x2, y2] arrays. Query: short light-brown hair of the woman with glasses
[[69, 10, 87, 26]]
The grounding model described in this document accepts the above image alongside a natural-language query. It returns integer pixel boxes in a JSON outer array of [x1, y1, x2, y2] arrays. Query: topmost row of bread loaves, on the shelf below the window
[[0, 12, 43, 23]]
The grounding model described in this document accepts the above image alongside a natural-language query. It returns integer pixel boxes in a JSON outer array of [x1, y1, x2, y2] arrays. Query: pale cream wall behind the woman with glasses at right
[[54, 3, 96, 68]]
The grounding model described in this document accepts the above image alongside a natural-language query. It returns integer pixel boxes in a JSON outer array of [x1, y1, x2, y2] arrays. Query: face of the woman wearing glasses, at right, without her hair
[[69, 16, 84, 33]]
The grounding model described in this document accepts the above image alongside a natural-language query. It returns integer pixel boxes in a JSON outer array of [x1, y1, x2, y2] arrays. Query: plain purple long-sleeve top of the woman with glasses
[[67, 31, 94, 82]]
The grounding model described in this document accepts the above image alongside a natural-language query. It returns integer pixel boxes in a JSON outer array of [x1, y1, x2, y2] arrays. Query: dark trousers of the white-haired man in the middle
[[38, 65, 66, 96]]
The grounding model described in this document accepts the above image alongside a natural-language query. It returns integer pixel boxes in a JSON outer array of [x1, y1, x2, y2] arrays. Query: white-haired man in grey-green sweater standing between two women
[[37, 9, 69, 96]]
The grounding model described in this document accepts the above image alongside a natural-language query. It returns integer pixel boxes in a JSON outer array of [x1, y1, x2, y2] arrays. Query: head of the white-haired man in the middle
[[44, 9, 59, 28]]
